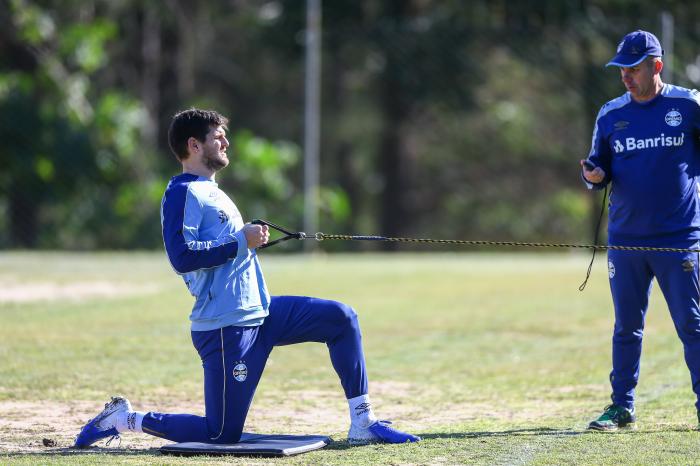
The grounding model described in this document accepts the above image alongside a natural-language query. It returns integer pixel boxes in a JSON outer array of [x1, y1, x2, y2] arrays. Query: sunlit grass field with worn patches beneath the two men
[[0, 252, 700, 465]]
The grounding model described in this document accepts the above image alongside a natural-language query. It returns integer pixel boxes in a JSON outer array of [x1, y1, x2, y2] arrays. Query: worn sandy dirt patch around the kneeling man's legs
[[0, 382, 584, 453]]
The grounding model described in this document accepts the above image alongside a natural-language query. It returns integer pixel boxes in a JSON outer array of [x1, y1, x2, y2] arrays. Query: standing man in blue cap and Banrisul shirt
[[581, 30, 700, 431]]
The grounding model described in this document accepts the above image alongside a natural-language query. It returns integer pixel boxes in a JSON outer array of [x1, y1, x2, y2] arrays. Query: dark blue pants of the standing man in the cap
[[608, 246, 700, 410]]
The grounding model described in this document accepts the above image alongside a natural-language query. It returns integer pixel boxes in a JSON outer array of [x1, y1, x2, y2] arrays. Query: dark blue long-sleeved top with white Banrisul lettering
[[587, 84, 700, 246]]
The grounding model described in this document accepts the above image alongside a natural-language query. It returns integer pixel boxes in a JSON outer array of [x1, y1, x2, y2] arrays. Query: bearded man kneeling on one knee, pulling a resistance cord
[[75, 109, 420, 448]]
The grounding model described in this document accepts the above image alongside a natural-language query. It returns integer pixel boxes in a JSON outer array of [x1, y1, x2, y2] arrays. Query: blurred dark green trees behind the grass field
[[0, 0, 700, 250]]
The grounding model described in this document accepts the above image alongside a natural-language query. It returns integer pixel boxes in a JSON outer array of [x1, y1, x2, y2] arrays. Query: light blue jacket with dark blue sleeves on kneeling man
[[161, 173, 270, 331]]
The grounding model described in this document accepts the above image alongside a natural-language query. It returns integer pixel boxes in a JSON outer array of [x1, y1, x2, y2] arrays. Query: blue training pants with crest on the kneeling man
[[142, 296, 367, 443]]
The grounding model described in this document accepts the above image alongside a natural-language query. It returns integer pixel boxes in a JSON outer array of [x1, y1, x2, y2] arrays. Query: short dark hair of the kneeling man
[[168, 108, 228, 160]]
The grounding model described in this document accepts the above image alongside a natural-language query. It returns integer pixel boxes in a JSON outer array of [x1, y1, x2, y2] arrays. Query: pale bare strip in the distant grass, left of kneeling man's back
[[0, 281, 159, 304]]
